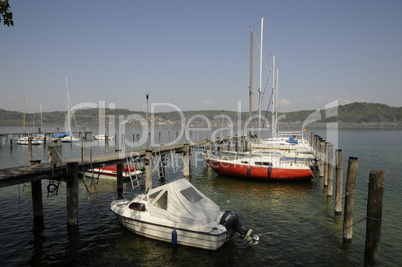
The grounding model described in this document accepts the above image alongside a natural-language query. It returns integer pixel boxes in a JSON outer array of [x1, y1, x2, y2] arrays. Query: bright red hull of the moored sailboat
[[206, 159, 314, 181]]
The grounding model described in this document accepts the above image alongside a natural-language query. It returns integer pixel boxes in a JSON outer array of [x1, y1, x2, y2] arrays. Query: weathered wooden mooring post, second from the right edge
[[343, 157, 359, 243]]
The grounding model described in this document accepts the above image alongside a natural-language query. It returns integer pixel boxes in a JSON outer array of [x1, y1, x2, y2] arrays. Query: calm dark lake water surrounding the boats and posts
[[0, 130, 402, 266]]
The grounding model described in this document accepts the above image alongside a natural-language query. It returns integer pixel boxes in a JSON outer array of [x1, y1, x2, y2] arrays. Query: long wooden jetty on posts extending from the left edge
[[0, 136, 246, 226]]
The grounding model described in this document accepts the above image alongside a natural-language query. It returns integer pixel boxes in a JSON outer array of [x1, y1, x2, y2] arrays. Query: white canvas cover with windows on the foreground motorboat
[[146, 178, 220, 225]]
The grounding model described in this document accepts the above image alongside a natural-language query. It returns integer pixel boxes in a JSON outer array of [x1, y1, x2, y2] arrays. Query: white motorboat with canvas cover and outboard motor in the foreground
[[110, 178, 259, 250]]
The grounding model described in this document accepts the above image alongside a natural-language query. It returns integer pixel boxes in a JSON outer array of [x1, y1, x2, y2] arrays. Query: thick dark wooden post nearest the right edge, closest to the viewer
[[364, 171, 385, 266]]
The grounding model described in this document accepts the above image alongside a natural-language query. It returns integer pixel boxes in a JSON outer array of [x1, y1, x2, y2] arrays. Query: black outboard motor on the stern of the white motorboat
[[219, 210, 260, 245]]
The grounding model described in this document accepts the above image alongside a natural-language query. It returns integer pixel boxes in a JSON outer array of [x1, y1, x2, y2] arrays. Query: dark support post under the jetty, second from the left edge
[[67, 162, 78, 227]]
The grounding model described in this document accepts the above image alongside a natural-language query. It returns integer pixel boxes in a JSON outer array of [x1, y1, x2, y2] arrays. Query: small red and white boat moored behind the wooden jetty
[[85, 164, 142, 180]]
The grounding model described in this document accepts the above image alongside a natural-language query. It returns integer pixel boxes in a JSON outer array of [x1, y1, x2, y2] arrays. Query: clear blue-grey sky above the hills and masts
[[0, 0, 402, 112]]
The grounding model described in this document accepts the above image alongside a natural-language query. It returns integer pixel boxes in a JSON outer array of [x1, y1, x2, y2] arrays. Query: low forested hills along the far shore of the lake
[[0, 102, 402, 127]]
